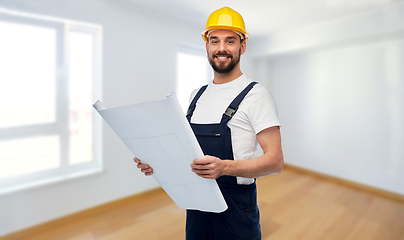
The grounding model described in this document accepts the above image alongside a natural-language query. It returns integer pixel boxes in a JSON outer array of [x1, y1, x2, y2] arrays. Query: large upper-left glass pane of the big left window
[[0, 21, 56, 128]]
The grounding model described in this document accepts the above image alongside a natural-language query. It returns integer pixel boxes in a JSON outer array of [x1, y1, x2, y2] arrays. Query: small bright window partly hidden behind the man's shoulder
[[176, 46, 212, 113]]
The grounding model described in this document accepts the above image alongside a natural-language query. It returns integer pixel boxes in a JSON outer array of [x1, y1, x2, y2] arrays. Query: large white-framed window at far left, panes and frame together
[[0, 8, 101, 193]]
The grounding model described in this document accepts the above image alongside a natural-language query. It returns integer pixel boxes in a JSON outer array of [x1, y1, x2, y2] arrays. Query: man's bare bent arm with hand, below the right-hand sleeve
[[191, 126, 283, 179]]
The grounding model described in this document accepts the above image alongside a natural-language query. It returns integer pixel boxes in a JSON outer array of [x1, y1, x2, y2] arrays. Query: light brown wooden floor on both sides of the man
[[0, 169, 404, 240]]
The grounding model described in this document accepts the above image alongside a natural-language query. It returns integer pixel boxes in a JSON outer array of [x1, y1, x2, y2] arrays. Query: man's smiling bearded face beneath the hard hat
[[206, 30, 246, 74]]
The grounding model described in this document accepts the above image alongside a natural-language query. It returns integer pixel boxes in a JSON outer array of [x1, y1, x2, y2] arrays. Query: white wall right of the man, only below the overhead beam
[[270, 39, 404, 194]]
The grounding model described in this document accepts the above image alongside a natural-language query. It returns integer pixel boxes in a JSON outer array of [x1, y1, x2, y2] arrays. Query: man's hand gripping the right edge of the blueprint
[[191, 155, 228, 179]]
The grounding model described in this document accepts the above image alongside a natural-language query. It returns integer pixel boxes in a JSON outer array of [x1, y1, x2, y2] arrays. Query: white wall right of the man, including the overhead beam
[[251, 4, 404, 194]]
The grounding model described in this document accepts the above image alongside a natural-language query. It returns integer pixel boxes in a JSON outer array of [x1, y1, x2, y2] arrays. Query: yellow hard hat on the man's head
[[202, 7, 248, 42]]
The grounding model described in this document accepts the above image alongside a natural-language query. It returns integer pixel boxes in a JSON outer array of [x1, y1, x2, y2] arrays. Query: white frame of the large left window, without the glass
[[0, 8, 103, 195]]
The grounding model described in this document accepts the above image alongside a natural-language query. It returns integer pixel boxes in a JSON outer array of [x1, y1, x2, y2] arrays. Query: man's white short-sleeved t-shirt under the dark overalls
[[190, 75, 280, 184]]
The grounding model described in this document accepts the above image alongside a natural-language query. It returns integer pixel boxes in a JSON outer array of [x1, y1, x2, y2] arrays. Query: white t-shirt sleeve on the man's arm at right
[[248, 84, 280, 134]]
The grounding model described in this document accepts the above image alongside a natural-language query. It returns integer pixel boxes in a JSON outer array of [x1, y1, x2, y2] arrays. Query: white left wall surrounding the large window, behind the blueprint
[[0, 0, 204, 236]]
